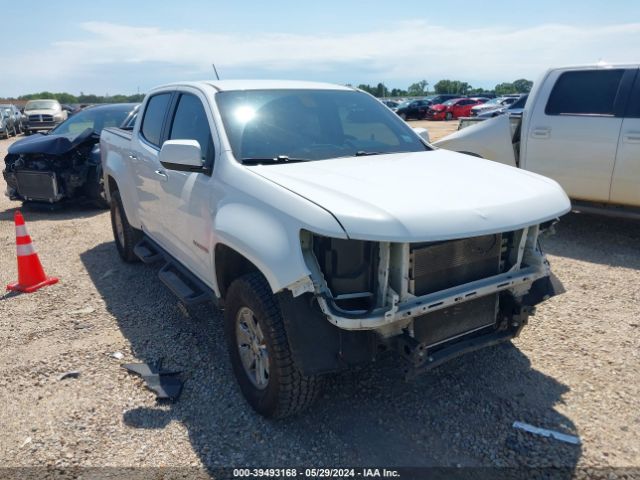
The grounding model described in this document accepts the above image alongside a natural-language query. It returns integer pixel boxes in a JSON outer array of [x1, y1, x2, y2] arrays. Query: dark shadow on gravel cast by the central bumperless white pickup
[[81, 242, 581, 470]]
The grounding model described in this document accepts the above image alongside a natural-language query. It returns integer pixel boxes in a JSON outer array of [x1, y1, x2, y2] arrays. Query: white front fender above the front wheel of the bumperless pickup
[[213, 203, 311, 293]]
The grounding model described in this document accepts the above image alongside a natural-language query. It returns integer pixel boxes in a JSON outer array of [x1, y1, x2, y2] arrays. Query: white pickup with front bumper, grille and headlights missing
[[100, 81, 570, 417]]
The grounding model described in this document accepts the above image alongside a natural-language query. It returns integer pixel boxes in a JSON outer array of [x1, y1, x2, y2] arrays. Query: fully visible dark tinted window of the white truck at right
[[545, 69, 624, 115]]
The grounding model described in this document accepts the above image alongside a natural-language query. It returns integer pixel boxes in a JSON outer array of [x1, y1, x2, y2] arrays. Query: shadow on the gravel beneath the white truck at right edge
[[543, 213, 640, 270]]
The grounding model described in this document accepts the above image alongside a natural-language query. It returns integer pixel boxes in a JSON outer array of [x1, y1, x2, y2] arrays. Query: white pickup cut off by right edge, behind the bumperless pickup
[[435, 64, 640, 218]]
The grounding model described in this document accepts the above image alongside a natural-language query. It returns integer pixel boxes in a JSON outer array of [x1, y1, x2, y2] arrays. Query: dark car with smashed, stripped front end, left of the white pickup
[[2, 103, 139, 208]]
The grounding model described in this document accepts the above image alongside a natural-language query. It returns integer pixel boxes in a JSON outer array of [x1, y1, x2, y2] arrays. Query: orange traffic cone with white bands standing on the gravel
[[7, 211, 58, 293]]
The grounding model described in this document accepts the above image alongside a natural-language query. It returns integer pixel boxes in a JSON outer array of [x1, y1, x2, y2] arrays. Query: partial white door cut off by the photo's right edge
[[611, 71, 640, 207]]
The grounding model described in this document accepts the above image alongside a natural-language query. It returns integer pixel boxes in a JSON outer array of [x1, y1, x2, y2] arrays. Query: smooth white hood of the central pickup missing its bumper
[[247, 150, 570, 242]]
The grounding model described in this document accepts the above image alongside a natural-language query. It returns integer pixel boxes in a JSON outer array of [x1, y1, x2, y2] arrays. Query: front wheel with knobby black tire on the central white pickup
[[224, 273, 322, 418]]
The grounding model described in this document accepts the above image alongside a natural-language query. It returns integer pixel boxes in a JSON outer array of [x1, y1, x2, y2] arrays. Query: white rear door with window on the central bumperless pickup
[[129, 91, 173, 248]]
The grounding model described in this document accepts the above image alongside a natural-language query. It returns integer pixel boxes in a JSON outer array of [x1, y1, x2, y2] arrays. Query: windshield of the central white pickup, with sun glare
[[216, 90, 428, 161]]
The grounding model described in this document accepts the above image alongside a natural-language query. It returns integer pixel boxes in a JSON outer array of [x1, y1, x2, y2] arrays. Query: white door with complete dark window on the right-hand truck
[[522, 68, 628, 202]]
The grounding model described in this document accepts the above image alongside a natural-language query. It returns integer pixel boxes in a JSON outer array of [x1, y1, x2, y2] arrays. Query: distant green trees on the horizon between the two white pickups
[[358, 78, 533, 98]]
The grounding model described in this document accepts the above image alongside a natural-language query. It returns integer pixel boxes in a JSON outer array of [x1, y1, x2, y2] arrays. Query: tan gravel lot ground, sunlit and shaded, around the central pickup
[[0, 122, 640, 469]]
